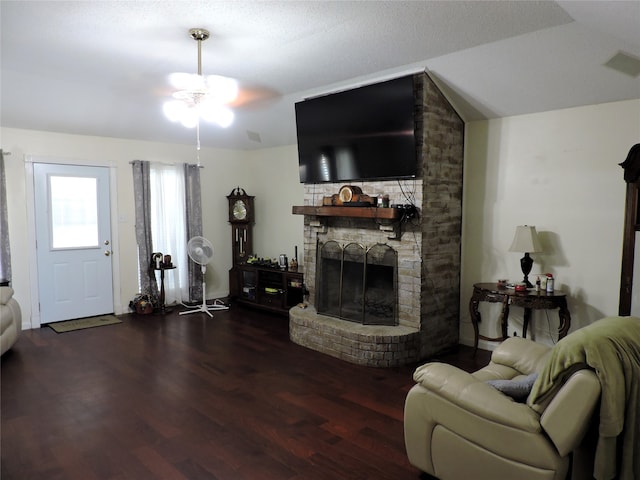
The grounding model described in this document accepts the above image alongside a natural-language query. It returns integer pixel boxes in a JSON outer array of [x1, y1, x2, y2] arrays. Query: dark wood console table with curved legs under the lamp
[[469, 283, 571, 351]]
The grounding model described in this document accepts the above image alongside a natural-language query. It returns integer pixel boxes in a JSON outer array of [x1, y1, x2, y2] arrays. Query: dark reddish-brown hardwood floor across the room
[[0, 306, 489, 480]]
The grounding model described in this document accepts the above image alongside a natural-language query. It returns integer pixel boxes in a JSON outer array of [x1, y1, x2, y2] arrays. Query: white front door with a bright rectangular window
[[33, 163, 113, 324]]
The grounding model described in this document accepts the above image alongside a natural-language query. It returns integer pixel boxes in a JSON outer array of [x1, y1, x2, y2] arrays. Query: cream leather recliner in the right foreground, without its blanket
[[404, 337, 601, 480]]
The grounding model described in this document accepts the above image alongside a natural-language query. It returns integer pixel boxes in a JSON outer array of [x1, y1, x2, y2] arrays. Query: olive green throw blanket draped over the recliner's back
[[529, 317, 640, 480]]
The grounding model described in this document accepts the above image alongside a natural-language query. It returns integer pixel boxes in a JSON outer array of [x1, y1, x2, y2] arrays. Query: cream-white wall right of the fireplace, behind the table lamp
[[460, 100, 640, 348]]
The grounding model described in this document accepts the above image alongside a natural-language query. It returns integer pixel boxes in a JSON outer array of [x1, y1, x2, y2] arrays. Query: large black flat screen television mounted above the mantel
[[295, 75, 418, 183]]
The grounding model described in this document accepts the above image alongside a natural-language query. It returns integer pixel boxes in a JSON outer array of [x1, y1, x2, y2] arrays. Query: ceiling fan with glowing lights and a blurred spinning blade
[[163, 28, 275, 128]]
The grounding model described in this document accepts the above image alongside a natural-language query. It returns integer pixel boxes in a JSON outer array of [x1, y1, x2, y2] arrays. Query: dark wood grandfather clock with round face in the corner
[[227, 187, 254, 267]]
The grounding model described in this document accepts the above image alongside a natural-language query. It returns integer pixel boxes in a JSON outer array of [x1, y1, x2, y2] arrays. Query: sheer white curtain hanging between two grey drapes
[[150, 162, 189, 304]]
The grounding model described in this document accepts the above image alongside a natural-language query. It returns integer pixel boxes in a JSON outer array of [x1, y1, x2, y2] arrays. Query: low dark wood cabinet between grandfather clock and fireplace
[[229, 264, 304, 314]]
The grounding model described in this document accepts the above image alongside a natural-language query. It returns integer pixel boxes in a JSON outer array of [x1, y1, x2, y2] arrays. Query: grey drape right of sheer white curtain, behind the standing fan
[[184, 163, 206, 302]]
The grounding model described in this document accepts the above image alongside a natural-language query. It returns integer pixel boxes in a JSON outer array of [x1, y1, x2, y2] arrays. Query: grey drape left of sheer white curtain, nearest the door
[[131, 160, 159, 297]]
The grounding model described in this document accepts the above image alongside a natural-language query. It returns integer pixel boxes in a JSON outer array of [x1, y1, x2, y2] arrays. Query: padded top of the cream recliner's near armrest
[[413, 362, 541, 433]]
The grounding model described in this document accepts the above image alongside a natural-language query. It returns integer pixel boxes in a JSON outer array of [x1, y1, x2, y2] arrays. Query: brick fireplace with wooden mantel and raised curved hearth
[[289, 73, 464, 367]]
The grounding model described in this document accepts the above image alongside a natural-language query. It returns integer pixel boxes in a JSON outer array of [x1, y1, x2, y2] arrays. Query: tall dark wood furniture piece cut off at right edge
[[618, 143, 640, 316]]
